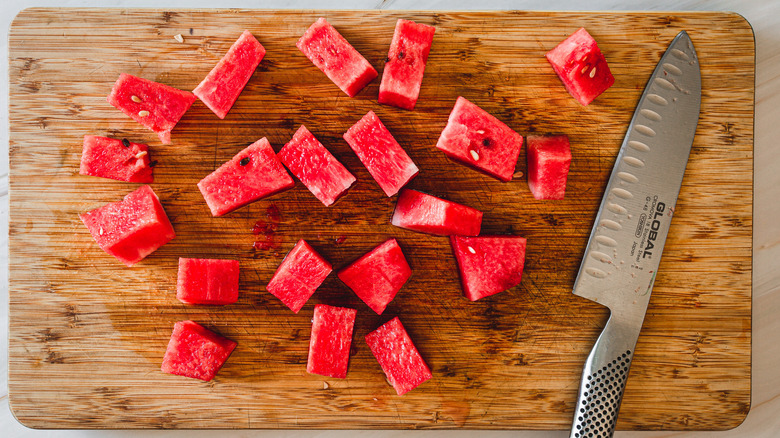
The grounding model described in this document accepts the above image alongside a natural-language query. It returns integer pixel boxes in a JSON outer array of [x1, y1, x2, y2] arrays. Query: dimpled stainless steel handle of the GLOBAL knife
[[569, 315, 641, 438]]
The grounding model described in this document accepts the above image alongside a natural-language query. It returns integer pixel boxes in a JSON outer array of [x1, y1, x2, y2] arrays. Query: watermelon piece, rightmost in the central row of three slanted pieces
[[344, 111, 419, 196]]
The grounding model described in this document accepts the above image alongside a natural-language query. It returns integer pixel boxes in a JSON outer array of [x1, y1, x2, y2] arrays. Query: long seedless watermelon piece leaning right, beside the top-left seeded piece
[[192, 30, 265, 119]]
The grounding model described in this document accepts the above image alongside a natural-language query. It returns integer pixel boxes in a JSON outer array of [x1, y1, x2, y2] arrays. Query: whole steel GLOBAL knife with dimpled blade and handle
[[570, 31, 701, 438]]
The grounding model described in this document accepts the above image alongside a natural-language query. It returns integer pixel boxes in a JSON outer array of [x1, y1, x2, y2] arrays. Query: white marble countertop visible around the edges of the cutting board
[[0, 0, 780, 438]]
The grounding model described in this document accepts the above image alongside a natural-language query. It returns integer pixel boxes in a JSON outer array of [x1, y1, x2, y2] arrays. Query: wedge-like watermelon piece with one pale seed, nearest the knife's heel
[[450, 236, 526, 301]]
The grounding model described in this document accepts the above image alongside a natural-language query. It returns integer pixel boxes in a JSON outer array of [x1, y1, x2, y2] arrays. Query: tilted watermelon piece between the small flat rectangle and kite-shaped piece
[[266, 239, 333, 313]]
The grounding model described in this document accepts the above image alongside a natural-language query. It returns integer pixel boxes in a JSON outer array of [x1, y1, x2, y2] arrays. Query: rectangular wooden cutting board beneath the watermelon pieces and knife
[[9, 9, 755, 429]]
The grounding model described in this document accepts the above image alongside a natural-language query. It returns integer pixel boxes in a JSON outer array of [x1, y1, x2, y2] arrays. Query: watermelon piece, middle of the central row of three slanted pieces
[[278, 125, 355, 207]]
